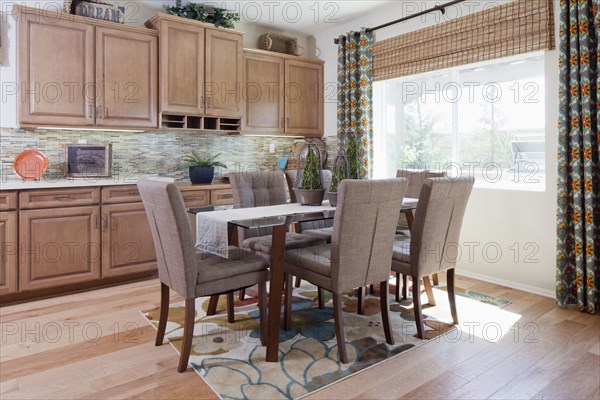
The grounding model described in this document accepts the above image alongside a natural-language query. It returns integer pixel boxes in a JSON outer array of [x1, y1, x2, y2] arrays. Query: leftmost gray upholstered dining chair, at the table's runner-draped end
[[138, 180, 269, 372]]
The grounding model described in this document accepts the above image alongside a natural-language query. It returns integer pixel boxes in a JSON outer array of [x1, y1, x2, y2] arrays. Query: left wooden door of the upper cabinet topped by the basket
[[243, 53, 285, 134]]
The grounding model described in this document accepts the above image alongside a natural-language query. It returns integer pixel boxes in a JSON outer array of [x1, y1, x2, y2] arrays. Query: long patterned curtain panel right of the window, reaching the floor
[[556, 0, 600, 313]]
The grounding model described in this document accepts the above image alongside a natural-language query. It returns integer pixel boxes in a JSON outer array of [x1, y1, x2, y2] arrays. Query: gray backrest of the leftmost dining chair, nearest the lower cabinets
[[137, 180, 198, 298]]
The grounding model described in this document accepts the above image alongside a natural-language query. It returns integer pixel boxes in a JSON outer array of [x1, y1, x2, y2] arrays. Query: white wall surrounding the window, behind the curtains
[[315, 1, 559, 296]]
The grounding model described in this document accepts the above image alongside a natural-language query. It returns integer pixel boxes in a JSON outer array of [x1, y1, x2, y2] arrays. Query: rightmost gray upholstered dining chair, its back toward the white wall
[[392, 177, 474, 339]]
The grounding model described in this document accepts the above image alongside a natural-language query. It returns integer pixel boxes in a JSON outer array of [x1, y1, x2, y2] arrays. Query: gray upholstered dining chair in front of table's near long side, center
[[284, 179, 407, 363]]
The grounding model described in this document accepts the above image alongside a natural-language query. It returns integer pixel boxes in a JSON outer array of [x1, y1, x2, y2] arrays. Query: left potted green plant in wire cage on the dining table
[[294, 142, 325, 206]]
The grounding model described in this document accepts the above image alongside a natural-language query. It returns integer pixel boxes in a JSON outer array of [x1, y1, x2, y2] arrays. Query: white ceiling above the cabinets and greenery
[[157, 0, 394, 35]]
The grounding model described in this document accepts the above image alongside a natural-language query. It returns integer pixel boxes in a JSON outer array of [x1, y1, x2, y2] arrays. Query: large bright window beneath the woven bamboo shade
[[374, 54, 545, 190]]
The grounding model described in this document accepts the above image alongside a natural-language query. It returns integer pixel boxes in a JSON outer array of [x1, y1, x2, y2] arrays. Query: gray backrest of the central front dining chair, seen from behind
[[331, 178, 408, 290]]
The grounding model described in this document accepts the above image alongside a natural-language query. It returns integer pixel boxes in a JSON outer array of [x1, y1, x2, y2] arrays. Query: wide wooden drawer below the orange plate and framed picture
[[19, 187, 100, 209]]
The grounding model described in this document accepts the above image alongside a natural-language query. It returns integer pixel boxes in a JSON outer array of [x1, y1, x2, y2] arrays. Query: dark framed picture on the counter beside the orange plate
[[65, 144, 112, 178]]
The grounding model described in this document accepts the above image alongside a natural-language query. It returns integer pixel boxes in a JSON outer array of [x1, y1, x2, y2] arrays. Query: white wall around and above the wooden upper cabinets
[[0, 0, 311, 128]]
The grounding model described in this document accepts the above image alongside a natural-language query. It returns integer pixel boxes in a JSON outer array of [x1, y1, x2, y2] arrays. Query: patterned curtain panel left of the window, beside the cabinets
[[337, 29, 373, 179]]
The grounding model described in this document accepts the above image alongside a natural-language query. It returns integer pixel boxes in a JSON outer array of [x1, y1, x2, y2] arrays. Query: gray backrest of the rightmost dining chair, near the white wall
[[410, 177, 475, 277]]
